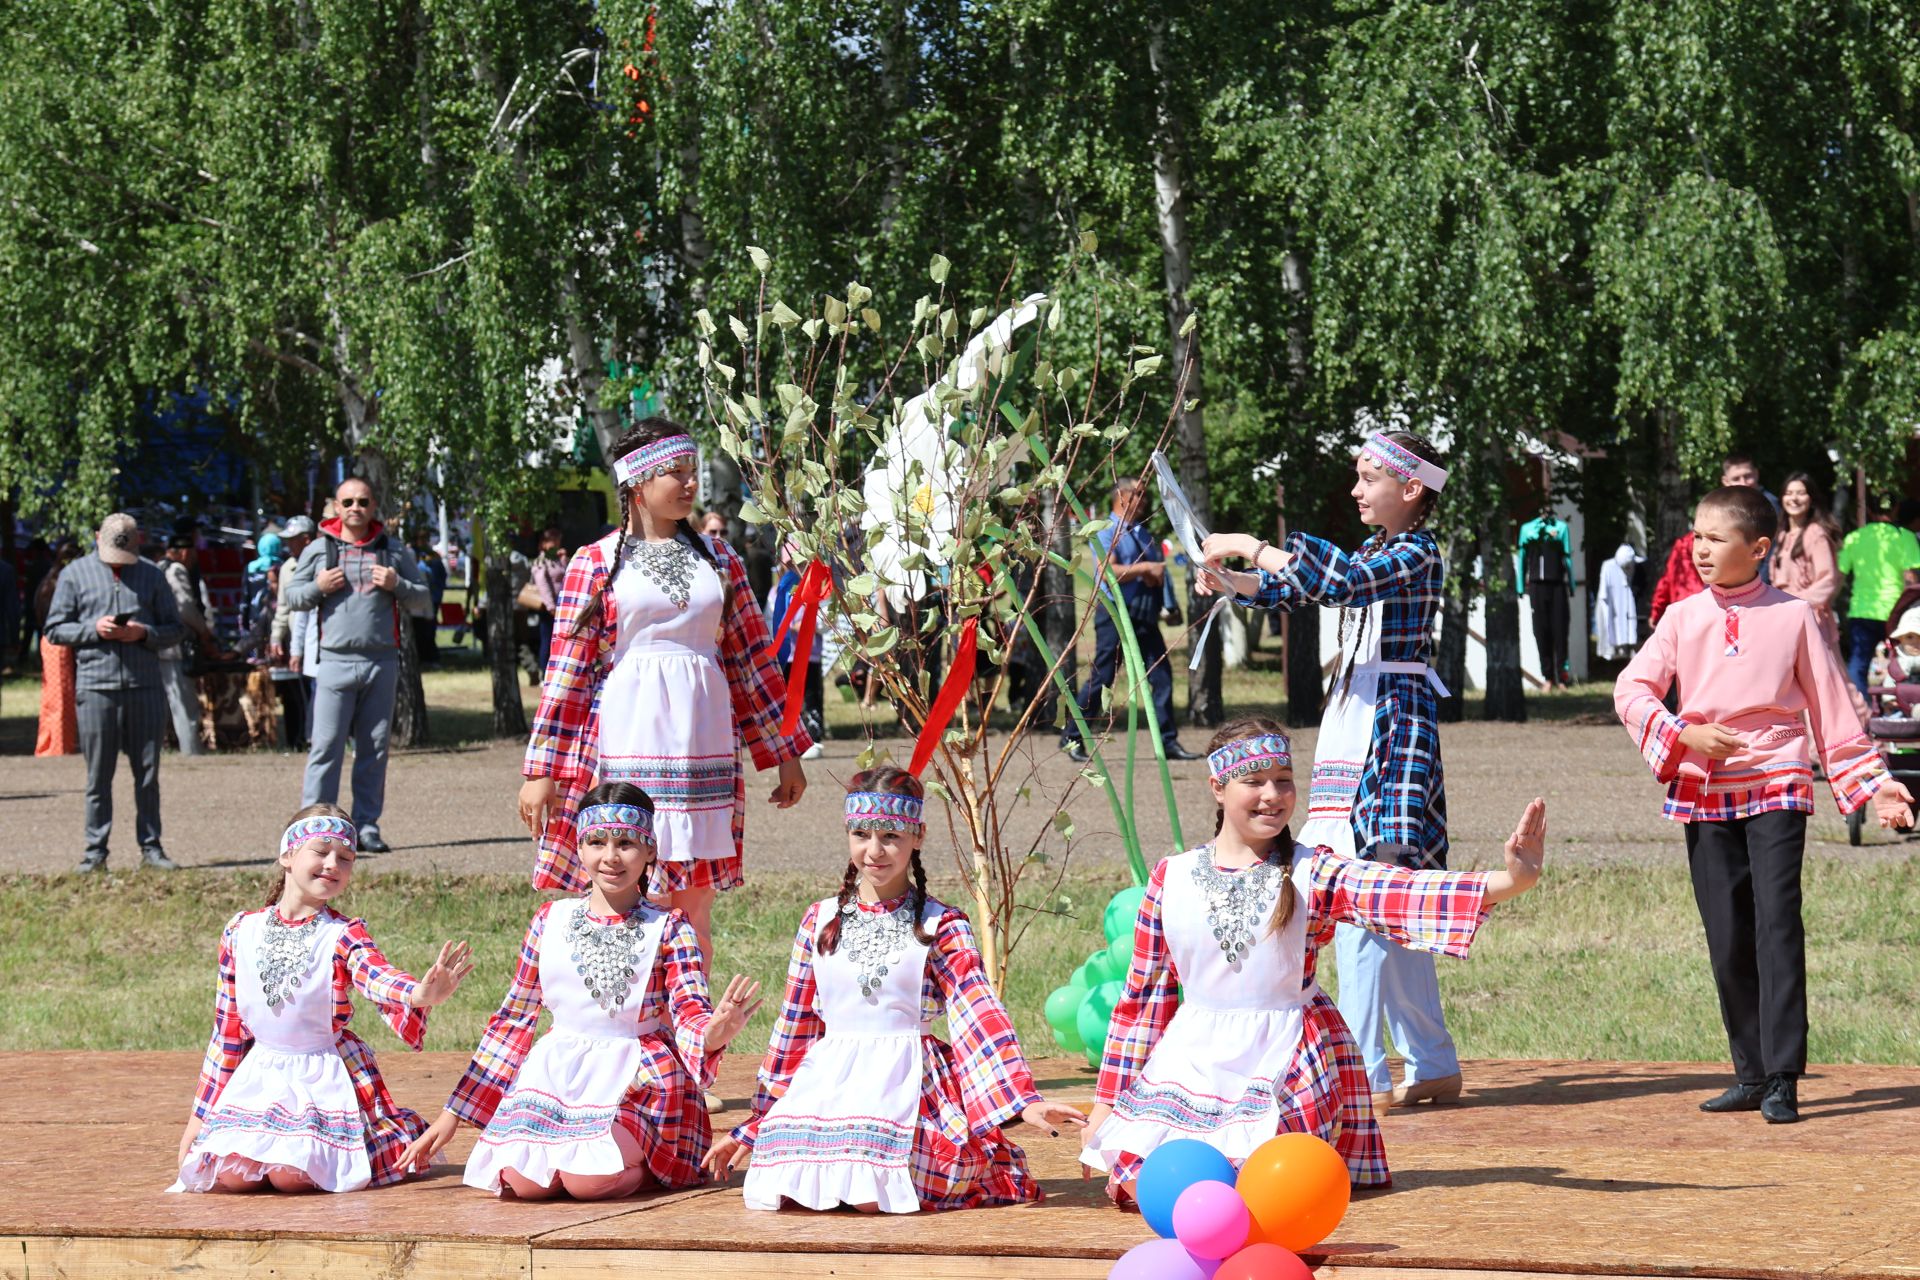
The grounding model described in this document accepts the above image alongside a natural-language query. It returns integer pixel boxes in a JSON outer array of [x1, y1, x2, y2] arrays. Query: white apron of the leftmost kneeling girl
[[167, 908, 372, 1192]]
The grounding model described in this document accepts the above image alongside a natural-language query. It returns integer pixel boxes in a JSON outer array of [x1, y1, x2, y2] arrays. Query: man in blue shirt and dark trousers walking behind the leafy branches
[[1060, 480, 1198, 762]]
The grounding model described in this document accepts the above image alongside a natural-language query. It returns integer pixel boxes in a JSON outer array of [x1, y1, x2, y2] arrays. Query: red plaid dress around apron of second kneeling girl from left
[[447, 902, 720, 1188]]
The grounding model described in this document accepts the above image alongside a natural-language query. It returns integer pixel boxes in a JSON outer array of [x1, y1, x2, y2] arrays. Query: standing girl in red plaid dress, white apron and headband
[[520, 416, 812, 960]]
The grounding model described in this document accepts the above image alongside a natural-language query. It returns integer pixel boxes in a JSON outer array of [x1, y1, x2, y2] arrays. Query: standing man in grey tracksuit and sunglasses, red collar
[[280, 478, 428, 854]]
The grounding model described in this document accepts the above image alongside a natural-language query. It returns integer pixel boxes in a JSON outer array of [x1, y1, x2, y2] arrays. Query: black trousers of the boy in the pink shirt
[[1686, 812, 1807, 1084]]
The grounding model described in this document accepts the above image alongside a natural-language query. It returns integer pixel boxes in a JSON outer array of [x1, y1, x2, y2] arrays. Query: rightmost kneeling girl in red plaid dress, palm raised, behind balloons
[[1081, 716, 1546, 1205]]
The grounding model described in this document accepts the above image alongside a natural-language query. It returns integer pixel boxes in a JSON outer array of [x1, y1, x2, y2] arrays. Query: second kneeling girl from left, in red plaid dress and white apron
[[401, 783, 760, 1199]]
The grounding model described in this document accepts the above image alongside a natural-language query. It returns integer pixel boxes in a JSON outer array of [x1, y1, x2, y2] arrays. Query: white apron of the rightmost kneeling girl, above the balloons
[[1081, 844, 1319, 1173]]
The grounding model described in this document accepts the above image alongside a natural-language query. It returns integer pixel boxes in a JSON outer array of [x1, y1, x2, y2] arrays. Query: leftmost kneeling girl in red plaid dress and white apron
[[167, 804, 472, 1192]]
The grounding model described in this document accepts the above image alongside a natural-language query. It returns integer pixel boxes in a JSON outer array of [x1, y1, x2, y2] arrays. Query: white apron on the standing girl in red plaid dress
[[599, 539, 739, 862]]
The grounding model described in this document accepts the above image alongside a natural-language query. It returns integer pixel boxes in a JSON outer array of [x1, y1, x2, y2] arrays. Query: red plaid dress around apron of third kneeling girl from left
[[733, 898, 1043, 1209]]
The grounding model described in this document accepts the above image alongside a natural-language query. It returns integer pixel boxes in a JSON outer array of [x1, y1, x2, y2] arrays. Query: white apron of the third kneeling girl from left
[[745, 898, 939, 1213]]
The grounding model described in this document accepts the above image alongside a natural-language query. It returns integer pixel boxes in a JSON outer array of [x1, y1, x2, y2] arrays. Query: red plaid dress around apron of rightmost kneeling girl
[[1094, 848, 1488, 1197]]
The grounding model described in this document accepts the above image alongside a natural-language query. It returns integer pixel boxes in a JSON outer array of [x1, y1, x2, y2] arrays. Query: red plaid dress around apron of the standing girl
[[520, 533, 814, 892]]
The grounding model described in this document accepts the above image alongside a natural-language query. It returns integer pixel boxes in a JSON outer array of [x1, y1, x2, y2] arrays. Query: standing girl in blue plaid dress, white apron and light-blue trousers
[[1200, 432, 1461, 1111]]
